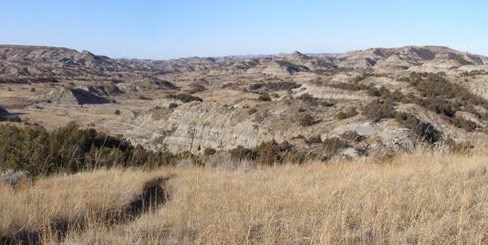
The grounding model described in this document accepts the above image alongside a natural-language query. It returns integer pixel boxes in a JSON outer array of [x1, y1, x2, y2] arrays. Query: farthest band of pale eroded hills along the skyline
[[0, 45, 488, 82]]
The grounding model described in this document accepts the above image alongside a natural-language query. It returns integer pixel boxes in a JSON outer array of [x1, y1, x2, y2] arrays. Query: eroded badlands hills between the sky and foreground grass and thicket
[[0, 46, 488, 165]]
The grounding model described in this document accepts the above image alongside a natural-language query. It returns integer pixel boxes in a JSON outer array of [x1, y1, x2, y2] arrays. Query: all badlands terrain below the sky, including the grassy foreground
[[0, 45, 488, 244]]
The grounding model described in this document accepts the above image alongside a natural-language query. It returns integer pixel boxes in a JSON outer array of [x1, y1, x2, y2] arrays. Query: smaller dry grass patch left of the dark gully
[[0, 169, 172, 243]]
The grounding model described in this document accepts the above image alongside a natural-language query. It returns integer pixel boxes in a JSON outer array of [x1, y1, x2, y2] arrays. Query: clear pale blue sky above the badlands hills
[[0, 0, 488, 59]]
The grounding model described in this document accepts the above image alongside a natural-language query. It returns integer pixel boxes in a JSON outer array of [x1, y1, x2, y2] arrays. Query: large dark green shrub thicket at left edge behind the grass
[[0, 123, 174, 176]]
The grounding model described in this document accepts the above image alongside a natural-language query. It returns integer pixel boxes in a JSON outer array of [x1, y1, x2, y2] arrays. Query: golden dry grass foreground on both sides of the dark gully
[[0, 153, 488, 244]]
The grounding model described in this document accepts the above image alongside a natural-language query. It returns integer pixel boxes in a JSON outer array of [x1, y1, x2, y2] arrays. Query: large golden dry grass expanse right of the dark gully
[[61, 153, 488, 244]]
